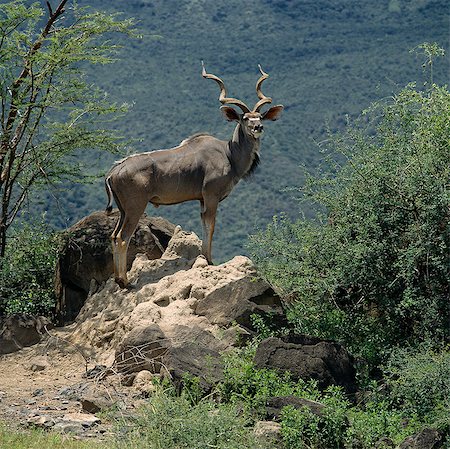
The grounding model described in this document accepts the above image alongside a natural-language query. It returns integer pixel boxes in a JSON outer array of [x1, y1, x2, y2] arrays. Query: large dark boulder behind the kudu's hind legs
[[55, 211, 175, 324]]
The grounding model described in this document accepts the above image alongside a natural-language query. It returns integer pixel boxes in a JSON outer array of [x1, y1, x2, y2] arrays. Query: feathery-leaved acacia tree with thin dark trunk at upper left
[[0, 0, 133, 257]]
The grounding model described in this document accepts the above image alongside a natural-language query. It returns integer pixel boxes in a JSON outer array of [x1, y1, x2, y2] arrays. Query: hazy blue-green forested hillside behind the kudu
[[33, 0, 449, 261]]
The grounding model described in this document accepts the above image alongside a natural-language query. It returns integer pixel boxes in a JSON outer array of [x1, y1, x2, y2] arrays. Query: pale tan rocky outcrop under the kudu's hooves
[[67, 227, 282, 389]]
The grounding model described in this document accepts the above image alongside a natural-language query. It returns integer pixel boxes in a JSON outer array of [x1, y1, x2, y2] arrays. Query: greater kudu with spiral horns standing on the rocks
[[105, 62, 283, 287]]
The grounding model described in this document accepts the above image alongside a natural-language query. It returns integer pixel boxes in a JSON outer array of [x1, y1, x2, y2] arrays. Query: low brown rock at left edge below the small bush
[[0, 314, 53, 355]]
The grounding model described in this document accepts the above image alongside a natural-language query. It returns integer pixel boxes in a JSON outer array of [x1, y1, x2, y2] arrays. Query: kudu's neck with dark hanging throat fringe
[[229, 123, 260, 179]]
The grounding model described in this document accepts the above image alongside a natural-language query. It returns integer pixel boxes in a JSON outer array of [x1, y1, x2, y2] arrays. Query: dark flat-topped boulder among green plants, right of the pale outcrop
[[254, 335, 356, 394]]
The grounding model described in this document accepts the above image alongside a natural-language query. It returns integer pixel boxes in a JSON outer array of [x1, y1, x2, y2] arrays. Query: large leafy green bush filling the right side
[[249, 47, 450, 366]]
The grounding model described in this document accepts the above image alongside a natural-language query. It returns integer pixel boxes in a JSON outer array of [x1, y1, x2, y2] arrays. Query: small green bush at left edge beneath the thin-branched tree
[[0, 216, 58, 317]]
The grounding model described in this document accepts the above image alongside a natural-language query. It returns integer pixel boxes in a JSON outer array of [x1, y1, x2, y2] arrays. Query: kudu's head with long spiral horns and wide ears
[[202, 61, 283, 139]]
